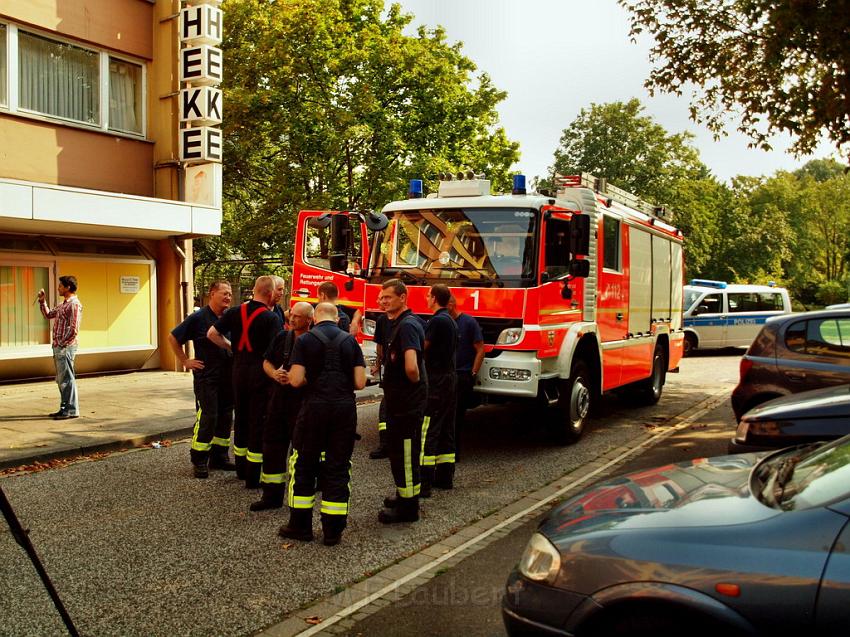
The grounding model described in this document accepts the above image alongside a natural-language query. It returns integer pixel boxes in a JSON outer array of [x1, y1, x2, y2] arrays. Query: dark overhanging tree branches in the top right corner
[[618, 0, 850, 155]]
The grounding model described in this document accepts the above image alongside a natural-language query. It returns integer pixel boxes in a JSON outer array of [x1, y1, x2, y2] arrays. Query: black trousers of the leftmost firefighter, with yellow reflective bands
[[192, 365, 233, 451]]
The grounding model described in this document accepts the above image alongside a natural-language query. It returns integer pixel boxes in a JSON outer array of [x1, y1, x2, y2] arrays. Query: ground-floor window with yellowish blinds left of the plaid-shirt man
[[0, 265, 50, 347]]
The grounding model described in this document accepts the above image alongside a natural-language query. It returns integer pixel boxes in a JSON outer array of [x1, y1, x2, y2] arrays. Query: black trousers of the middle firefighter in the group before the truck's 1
[[422, 372, 457, 467]]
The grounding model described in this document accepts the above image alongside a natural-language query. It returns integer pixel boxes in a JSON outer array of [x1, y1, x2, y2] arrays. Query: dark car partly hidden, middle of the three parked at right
[[729, 385, 850, 453]]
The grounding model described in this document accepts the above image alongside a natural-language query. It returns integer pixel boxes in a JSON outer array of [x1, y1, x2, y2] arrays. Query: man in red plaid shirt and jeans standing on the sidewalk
[[38, 276, 83, 420]]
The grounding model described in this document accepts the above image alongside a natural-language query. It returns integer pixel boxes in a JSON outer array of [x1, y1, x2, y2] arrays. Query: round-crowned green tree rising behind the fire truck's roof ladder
[[550, 99, 708, 204]]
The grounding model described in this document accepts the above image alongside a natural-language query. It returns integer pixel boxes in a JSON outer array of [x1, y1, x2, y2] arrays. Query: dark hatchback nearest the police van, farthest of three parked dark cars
[[732, 310, 850, 420]]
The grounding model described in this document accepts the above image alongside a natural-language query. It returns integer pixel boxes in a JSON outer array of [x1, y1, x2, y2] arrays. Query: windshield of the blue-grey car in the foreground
[[756, 436, 850, 511]]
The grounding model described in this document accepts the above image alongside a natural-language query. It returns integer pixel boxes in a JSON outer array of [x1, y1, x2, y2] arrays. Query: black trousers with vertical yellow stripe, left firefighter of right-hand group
[[384, 383, 426, 498]]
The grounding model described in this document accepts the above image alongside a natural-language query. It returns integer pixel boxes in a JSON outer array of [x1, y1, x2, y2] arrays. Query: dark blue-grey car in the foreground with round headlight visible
[[502, 437, 850, 637]]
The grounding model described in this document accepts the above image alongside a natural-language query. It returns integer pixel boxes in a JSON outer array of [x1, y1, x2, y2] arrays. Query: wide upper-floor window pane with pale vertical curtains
[[18, 31, 100, 124]]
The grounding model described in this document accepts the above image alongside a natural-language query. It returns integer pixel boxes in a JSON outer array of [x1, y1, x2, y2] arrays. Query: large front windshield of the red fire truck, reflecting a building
[[369, 208, 537, 287]]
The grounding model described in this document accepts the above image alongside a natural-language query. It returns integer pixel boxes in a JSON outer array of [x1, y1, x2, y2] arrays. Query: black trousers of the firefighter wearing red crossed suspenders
[[233, 361, 269, 477]]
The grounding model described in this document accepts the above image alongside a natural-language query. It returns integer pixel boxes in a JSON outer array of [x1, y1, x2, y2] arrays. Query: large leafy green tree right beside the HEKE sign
[[197, 0, 519, 270]]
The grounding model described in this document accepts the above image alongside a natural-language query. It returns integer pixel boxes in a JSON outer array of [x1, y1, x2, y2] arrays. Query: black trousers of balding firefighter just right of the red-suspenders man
[[260, 383, 301, 484]]
